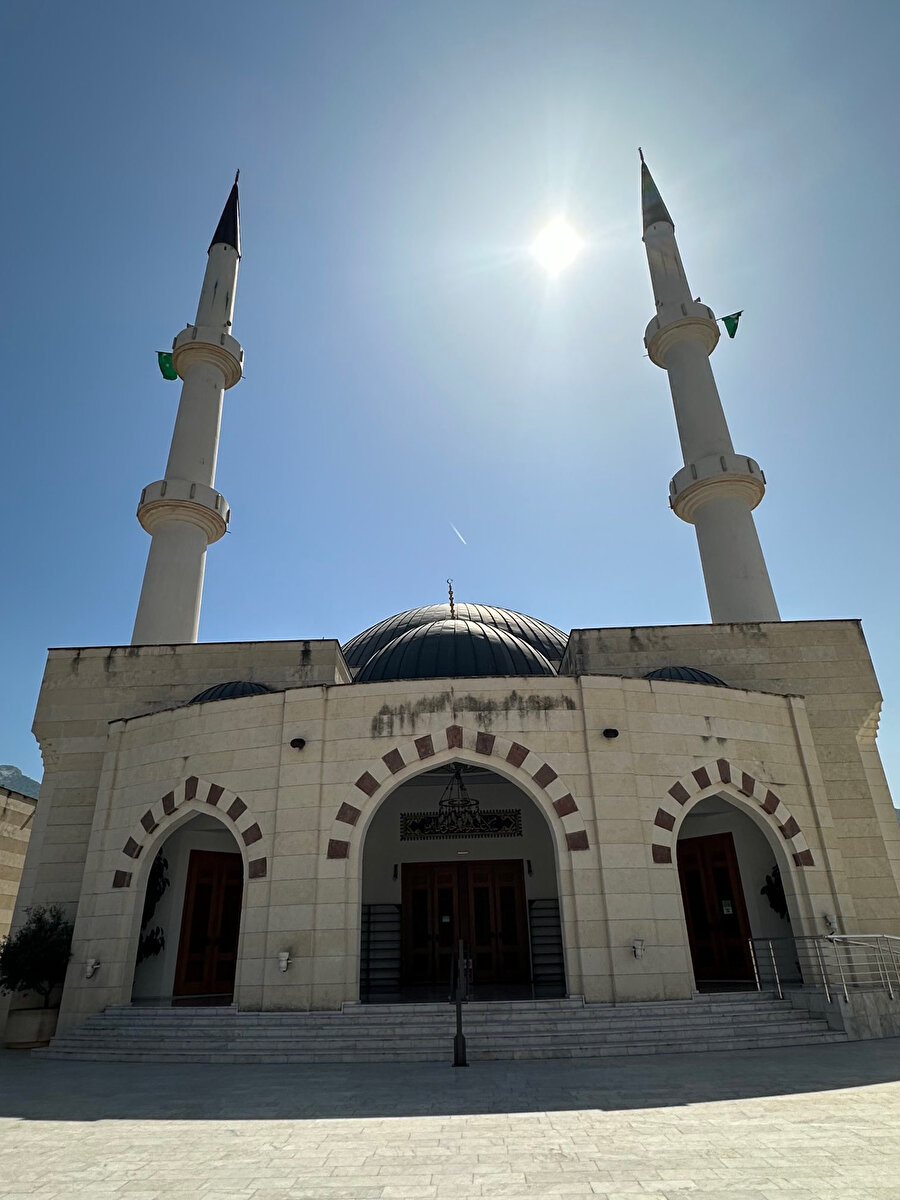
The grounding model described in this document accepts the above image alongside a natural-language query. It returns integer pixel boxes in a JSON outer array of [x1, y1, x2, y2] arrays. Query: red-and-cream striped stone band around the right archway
[[650, 758, 815, 866]]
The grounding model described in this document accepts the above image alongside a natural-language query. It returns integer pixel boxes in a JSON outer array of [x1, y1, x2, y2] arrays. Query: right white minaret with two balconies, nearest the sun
[[641, 154, 780, 622]]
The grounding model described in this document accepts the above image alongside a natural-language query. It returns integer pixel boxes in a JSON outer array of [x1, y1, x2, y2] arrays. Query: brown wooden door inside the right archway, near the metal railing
[[678, 833, 754, 989]]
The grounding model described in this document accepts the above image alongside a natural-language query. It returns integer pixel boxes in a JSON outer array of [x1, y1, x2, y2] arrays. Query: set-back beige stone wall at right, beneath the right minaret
[[564, 620, 900, 934]]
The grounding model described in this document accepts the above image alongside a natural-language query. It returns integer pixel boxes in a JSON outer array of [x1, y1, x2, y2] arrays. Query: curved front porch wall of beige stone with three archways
[[47, 677, 852, 1024]]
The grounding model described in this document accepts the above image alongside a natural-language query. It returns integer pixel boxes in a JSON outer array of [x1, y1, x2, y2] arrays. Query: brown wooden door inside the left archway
[[173, 850, 244, 1003]]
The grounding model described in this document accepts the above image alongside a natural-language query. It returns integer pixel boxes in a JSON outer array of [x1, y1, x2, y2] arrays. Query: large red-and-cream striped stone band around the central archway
[[325, 725, 590, 858]]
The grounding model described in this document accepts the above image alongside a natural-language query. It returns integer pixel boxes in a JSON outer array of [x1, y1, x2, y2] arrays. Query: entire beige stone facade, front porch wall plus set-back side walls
[[8, 622, 900, 1028]]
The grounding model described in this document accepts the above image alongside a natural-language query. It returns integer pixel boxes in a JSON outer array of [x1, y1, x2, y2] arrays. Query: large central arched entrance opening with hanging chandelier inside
[[360, 762, 565, 1002]]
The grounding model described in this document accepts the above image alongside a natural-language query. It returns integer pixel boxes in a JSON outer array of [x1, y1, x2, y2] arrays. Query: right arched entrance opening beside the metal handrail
[[677, 796, 794, 991]]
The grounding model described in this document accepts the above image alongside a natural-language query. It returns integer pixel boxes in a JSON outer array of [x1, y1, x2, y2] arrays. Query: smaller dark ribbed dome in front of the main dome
[[356, 617, 556, 683]]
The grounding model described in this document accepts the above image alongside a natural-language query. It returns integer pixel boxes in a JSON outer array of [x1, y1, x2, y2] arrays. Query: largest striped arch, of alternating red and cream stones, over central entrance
[[325, 725, 590, 859]]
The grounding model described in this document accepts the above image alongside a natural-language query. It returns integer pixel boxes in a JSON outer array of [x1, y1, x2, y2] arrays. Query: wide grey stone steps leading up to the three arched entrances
[[32, 992, 846, 1063]]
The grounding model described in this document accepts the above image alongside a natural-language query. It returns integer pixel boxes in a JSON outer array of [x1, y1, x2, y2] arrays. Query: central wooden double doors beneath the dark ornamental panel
[[401, 860, 530, 1000]]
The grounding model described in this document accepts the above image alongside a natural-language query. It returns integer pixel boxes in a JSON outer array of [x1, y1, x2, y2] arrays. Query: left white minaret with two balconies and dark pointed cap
[[131, 175, 244, 646]]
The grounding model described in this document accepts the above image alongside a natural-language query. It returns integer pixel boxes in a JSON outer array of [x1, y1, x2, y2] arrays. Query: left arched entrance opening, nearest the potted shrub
[[132, 814, 244, 1004]]
